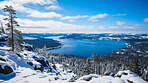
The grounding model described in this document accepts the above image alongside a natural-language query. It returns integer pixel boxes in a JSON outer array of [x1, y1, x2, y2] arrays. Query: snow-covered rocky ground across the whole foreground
[[0, 33, 148, 83]]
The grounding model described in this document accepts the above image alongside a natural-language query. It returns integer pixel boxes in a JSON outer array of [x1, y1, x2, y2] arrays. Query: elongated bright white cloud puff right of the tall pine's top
[[28, 11, 62, 18]]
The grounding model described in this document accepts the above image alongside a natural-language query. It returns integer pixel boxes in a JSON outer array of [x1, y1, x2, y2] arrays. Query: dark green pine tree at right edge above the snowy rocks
[[128, 55, 141, 76]]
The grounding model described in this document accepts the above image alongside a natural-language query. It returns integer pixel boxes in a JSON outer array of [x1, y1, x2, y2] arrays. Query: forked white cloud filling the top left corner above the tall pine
[[0, 0, 62, 18]]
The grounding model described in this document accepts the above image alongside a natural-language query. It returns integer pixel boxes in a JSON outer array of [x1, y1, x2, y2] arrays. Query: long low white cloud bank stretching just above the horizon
[[0, 14, 144, 33]]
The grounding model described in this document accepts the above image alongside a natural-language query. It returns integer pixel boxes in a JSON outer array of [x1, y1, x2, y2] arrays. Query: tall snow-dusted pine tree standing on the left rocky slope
[[3, 5, 23, 51]]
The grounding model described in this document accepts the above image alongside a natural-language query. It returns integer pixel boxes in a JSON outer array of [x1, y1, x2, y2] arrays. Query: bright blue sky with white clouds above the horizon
[[0, 0, 148, 33]]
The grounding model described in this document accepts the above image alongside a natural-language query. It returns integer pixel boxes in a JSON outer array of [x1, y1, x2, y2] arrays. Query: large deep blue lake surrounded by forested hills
[[49, 37, 126, 57]]
